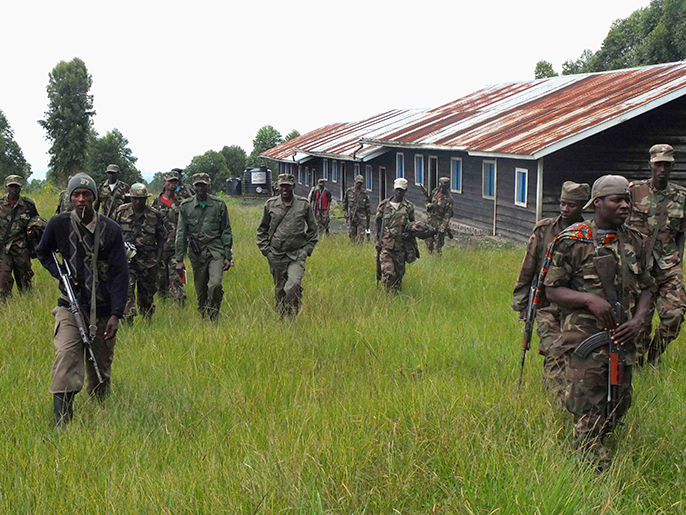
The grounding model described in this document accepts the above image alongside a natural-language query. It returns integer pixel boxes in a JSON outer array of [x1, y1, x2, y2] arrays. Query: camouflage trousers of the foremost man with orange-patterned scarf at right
[[565, 348, 634, 441]]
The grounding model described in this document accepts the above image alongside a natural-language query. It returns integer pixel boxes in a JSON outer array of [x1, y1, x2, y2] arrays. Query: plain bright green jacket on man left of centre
[[174, 195, 233, 262]]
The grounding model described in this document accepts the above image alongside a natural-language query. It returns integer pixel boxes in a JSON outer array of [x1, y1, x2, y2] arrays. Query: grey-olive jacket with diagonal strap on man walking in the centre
[[257, 195, 319, 259]]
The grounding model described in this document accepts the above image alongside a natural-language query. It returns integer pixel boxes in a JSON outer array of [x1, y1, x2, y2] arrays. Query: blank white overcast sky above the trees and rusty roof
[[0, 0, 649, 178]]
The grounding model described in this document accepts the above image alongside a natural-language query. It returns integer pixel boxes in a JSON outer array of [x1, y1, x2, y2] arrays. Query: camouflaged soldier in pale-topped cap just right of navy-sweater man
[[114, 183, 165, 324]]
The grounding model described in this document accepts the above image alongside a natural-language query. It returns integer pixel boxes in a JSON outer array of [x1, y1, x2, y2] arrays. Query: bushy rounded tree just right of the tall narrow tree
[[88, 128, 143, 185]]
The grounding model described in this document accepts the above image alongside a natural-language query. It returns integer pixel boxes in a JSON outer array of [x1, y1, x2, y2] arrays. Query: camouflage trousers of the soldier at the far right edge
[[637, 265, 686, 355]]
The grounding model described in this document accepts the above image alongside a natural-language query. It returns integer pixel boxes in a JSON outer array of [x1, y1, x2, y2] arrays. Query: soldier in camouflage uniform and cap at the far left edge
[[0, 175, 40, 301]]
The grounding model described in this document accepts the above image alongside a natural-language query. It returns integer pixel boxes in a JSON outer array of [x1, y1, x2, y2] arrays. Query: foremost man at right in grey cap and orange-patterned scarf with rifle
[[537, 175, 655, 470]]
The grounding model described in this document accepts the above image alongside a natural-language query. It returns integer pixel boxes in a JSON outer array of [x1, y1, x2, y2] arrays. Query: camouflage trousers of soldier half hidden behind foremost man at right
[[536, 306, 566, 402]]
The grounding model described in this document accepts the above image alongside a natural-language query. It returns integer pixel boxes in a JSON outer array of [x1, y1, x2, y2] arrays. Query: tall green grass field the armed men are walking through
[[0, 195, 686, 515]]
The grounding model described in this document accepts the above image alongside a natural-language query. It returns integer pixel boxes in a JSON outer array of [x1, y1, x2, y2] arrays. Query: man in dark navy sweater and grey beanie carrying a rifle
[[36, 173, 129, 428]]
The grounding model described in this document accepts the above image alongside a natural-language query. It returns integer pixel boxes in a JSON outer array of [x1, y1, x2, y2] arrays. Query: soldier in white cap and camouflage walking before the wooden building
[[375, 178, 414, 293]]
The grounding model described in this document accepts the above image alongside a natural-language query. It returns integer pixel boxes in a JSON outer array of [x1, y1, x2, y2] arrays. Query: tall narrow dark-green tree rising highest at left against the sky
[[38, 57, 95, 185]]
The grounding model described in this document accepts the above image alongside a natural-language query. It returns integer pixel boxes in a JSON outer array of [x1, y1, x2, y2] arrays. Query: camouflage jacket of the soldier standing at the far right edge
[[629, 179, 686, 270]]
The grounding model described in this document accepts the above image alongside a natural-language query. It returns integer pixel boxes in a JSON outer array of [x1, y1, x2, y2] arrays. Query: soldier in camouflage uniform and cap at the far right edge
[[629, 145, 686, 364]]
